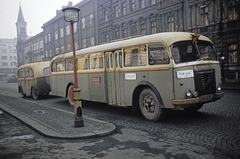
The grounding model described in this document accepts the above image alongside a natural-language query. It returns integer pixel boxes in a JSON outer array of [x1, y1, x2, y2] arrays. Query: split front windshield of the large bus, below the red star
[[171, 40, 217, 64]]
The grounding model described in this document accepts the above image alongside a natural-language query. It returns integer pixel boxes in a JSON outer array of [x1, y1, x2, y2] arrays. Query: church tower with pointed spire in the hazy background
[[16, 3, 27, 67]]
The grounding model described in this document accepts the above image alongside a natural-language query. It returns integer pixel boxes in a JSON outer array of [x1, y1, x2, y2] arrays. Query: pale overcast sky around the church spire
[[0, 0, 81, 39]]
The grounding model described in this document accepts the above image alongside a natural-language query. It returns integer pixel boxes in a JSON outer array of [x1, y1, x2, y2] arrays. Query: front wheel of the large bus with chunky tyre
[[139, 88, 166, 121]]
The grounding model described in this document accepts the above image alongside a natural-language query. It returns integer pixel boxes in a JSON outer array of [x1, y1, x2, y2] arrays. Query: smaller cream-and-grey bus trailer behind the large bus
[[17, 61, 51, 100]]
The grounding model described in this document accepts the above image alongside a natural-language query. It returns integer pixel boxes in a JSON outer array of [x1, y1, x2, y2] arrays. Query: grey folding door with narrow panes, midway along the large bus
[[105, 51, 122, 105]]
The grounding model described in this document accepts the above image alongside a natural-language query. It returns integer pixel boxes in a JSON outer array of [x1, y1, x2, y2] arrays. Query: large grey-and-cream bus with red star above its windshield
[[50, 32, 224, 121]]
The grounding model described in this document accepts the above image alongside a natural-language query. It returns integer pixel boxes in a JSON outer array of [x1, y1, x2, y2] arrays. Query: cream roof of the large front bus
[[53, 32, 212, 60]]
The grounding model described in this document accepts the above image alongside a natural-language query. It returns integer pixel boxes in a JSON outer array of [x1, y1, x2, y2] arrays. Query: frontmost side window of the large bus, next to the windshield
[[149, 44, 169, 65]]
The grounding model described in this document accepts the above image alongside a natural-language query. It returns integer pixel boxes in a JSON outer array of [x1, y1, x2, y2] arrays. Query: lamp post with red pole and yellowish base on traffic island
[[62, 7, 84, 127]]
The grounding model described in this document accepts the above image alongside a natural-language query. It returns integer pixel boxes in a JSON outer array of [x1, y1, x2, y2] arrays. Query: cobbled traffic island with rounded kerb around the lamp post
[[0, 99, 116, 139]]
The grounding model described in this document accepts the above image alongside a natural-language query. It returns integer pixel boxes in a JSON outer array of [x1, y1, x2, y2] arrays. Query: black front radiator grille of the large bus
[[194, 70, 216, 95]]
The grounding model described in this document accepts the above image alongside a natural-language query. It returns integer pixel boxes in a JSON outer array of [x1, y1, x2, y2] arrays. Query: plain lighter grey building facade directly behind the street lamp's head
[[42, 0, 98, 58]]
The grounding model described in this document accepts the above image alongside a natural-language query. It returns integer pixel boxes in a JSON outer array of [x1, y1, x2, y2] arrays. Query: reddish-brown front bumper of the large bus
[[172, 92, 224, 106]]
